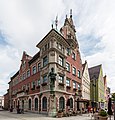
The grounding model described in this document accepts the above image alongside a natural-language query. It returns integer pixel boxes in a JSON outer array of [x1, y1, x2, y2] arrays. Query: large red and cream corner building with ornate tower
[[9, 12, 82, 116]]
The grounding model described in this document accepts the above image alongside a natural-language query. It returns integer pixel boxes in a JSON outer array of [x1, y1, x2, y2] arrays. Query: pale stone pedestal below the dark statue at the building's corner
[[48, 95, 57, 117]]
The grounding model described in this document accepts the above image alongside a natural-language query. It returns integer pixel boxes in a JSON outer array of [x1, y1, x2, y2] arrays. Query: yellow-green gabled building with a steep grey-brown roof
[[89, 65, 105, 108]]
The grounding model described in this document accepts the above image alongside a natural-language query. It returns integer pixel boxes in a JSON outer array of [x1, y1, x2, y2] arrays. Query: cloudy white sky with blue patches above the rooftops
[[0, 0, 115, 95]]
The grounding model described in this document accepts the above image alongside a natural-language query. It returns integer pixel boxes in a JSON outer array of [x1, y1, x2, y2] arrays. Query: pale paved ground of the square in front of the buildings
[[0, 111, 114, 120]]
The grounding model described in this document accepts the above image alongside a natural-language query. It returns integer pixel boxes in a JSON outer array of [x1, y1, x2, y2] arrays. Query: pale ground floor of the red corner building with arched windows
[[10, 92, 81, 116]]
